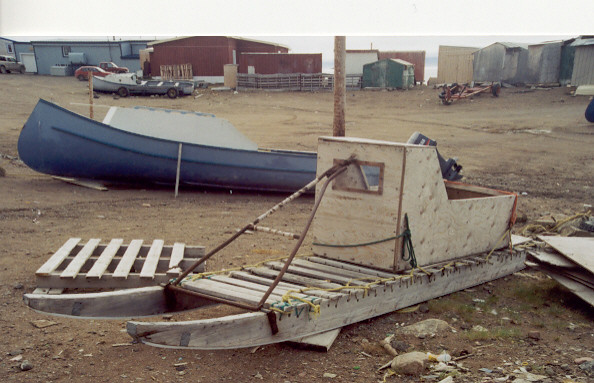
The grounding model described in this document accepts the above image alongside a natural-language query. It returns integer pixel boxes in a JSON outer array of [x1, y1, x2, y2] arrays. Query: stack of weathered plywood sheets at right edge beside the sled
[[527, 235, 594, 306]]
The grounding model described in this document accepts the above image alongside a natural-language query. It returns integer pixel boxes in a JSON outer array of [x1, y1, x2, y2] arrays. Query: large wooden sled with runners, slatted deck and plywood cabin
[[25, 137, 525, 349]]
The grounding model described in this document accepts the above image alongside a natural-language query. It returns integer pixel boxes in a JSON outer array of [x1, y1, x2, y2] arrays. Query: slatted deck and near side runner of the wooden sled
[[127, 251, 525, 349]]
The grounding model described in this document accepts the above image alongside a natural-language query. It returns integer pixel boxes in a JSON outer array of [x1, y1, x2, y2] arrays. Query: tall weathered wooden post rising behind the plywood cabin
[[332, 36, 346, 137]]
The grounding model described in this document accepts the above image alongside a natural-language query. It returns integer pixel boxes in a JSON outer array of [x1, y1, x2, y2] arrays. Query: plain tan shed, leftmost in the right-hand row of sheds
[[437, 45, 480, 84]]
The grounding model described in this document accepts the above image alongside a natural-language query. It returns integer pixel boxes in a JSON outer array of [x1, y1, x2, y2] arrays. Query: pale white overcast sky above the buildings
[[0, 0, 594, 76]]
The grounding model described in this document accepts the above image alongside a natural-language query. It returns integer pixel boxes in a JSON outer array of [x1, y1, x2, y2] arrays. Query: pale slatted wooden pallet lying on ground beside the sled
[[35, 238, 204, 291]]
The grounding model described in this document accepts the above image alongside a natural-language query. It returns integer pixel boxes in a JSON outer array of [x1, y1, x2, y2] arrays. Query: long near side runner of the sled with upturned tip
[[127, 253, 525, 349]]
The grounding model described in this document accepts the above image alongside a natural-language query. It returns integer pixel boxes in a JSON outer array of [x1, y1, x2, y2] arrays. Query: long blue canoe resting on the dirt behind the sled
[[18, 99, 316, 192]]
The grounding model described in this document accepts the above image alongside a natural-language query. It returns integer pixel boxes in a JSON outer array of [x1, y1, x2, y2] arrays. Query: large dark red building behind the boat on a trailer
[[149, 36, 289, 82]]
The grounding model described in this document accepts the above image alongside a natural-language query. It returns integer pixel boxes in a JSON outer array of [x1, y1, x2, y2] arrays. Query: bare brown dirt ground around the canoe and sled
[[0, 74, 594, 383]]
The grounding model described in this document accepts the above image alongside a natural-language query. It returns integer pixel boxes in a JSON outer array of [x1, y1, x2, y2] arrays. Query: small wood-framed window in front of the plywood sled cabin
[[332, 159, 384, 195]]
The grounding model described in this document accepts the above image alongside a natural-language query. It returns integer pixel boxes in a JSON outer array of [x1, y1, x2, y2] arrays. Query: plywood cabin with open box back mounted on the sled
[[313, 137, 517, 272]]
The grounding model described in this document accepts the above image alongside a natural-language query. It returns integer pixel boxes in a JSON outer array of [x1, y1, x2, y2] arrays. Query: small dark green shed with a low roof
[[363, 59, 415, 89]]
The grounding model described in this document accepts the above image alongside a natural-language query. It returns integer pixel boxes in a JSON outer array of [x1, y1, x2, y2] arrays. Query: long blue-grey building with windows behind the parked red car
[[31, 40, 149, 75]]
